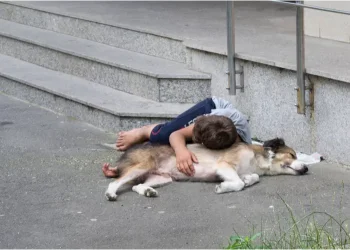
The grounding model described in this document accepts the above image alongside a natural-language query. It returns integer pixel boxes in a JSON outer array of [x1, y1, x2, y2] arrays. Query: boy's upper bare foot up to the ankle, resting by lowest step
[[116, 128, 145, 151]]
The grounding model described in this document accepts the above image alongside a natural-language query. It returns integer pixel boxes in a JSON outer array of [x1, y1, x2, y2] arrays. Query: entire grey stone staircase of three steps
[[0, 3, 211, 131]]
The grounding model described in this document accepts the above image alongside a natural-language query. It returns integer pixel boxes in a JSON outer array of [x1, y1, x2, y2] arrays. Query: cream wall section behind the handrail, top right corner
[[305, 1, 350, 43]]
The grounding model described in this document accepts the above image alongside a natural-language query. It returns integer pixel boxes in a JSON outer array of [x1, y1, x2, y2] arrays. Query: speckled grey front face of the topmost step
[[0, 2, 186, 63]]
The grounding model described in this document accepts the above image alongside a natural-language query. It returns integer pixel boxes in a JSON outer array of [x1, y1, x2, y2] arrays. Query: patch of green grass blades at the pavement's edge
[[225, 193, 350, 249]]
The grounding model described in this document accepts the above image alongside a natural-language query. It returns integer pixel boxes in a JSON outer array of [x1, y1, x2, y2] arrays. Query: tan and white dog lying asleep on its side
[[104, 138, 308, 201]]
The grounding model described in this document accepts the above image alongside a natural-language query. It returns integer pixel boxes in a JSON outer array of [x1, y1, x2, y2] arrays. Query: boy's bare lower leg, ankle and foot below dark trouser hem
[[117, 124, 158, 151]]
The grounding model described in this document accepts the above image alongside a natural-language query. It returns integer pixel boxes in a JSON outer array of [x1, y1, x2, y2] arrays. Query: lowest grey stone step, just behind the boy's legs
[[0, 55, 191, 131]]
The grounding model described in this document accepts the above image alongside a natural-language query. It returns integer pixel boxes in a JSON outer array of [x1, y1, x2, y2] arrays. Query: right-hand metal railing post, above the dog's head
[[296, 1, 305, 114]]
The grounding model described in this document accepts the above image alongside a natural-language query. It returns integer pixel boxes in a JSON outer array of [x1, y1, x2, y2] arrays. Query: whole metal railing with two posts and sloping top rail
[[227, 0, 350, 114]]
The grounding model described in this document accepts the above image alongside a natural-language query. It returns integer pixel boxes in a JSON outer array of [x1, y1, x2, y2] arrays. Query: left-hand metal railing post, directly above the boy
[[226, 0, 236, 95]]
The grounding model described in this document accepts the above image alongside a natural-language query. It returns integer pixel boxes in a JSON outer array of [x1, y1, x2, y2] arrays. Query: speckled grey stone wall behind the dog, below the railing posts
[[189, 49, 350, 164]]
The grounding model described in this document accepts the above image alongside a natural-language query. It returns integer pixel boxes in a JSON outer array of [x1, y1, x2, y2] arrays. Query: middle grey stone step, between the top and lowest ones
[[0, 20, 210, 103]]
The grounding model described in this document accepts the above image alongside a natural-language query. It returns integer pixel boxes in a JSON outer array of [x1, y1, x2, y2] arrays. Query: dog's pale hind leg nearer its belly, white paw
[[132, 175, 173, 197]]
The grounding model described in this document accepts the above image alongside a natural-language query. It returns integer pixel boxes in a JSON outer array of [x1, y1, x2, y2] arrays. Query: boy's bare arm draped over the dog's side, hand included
[[169, 124, 198, 176]]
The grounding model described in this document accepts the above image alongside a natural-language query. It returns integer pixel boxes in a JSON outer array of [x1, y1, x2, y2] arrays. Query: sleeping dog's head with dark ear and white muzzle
[[263, 138, 308, 175]]
